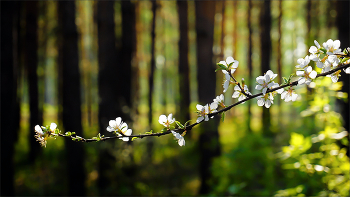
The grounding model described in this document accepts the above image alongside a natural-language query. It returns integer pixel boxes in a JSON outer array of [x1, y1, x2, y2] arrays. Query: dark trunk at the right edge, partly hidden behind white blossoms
[[336, 1, 350, 156]]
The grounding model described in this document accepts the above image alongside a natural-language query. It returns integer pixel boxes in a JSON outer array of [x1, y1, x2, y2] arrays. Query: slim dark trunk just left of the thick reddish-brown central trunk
[[177, 0, 190, 123]]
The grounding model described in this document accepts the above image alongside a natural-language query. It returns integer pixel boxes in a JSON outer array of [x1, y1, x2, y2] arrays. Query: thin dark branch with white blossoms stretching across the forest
[[34, 39, 350, 147]]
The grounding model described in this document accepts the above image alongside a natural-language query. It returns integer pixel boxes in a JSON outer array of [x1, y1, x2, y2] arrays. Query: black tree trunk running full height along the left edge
[[0, 1, 19, 196]]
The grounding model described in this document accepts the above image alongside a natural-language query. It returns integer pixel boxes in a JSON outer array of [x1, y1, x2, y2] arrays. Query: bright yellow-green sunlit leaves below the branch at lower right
[[276, 77, 350, 196]]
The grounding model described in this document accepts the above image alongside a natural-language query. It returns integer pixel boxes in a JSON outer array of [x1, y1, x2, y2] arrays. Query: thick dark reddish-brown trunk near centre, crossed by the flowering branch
[[195, 1, 220, 194]]
